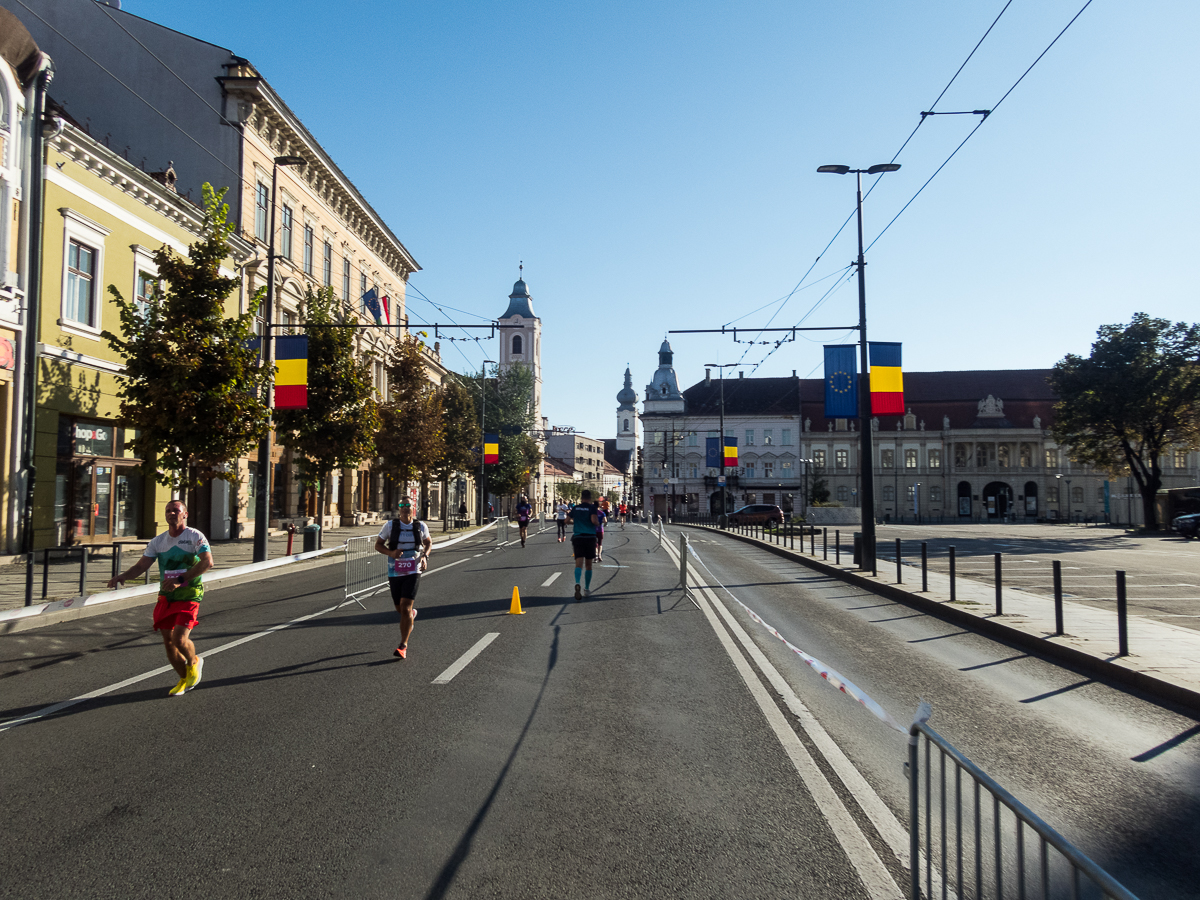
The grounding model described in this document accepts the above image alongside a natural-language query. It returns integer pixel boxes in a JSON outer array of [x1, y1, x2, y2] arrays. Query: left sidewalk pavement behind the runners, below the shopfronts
[[0, 522, 496, 635]]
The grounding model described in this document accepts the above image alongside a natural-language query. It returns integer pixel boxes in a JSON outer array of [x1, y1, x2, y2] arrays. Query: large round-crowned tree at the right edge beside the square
[[1049, 312, 1200, 530]]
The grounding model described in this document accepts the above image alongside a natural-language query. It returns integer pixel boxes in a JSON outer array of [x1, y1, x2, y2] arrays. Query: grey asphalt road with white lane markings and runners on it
[[0, 527, 1200, 900]]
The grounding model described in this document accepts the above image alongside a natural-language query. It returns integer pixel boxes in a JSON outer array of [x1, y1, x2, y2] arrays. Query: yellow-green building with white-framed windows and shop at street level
[[34, 124, 251, 548]]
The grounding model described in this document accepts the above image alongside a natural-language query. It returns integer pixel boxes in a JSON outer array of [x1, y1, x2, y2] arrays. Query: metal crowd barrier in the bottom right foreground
[[908, 720, 1136, 900]]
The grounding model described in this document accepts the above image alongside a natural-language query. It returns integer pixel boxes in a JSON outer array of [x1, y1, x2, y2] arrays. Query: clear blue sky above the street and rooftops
[[124, 0, 1200, 437]]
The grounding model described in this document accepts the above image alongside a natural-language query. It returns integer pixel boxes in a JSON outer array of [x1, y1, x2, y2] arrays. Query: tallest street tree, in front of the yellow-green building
[[102, 184, 269, 490]]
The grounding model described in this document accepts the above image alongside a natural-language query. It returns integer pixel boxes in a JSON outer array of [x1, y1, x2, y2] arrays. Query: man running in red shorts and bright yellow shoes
[[108, 500, 212, 697]]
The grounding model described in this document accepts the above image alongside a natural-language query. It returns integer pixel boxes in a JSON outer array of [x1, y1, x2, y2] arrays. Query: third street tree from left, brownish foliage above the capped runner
[[376, 334, 445, 494]]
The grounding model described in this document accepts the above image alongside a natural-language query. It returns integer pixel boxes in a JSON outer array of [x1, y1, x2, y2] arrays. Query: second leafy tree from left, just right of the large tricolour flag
[[275, 288, 379, 525]]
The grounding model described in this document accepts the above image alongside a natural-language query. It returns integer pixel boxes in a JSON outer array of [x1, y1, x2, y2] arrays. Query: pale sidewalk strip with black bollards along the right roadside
[[689, 526, 1200, 710]]
